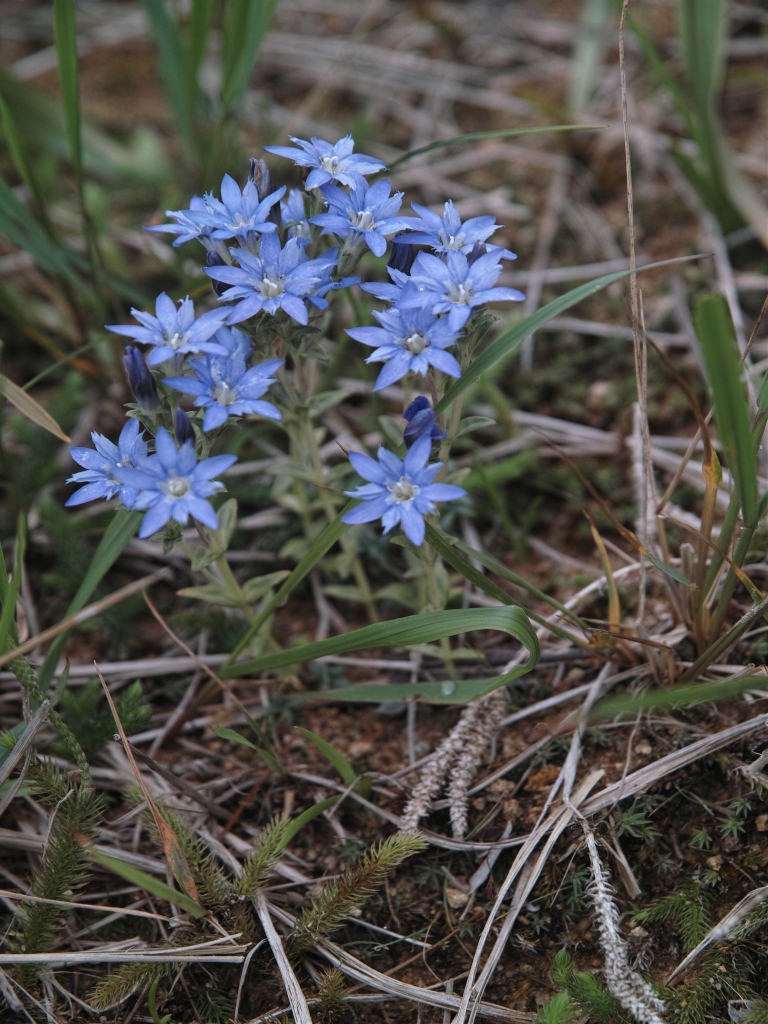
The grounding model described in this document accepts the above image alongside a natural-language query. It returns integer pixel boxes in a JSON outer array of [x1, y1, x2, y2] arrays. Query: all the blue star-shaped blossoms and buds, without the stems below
[[67, 136, 524, 545]]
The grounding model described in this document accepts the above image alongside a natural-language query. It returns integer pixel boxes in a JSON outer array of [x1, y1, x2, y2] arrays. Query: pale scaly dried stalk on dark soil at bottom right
[[584, 821, 665, 1024]]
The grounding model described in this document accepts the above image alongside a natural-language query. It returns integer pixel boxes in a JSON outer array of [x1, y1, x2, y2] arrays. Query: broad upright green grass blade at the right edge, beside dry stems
[[694, 294, 759, 529]]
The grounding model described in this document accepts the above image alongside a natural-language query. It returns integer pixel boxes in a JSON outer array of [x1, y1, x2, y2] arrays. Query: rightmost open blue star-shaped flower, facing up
[[399, 249, 525, 331]]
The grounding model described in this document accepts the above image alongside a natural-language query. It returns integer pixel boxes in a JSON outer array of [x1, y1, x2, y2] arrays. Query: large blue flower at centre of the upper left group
[[205, 234, 335, 324]]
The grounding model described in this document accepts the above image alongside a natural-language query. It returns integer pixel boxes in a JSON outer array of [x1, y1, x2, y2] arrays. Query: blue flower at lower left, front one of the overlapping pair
[[118, 427, 238, 539]]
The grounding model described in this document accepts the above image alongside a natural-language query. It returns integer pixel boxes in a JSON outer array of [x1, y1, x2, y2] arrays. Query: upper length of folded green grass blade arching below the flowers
[[227, 608, 539, 677]]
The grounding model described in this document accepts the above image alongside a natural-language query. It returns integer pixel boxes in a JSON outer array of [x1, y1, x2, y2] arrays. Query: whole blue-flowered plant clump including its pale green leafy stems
[[68, 136, 524, 609]]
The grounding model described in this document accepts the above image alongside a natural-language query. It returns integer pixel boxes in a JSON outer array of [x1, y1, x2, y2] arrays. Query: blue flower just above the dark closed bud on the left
[[106, 292, 226, 367]]
